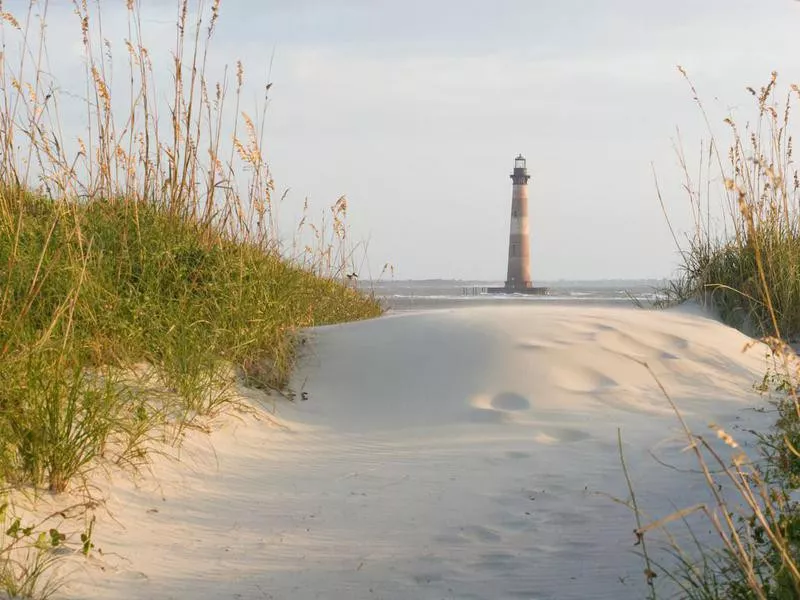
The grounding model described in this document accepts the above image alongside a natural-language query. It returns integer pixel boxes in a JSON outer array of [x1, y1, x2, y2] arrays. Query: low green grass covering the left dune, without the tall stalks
[[0, 193, 380, 491]]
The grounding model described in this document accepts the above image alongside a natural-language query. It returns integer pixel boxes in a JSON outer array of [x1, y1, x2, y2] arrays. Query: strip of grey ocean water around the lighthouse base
[[370, 279, 667, 312]]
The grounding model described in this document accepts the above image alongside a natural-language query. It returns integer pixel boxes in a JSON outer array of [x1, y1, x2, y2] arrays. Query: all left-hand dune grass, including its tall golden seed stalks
[[0, 0, 382, 598]]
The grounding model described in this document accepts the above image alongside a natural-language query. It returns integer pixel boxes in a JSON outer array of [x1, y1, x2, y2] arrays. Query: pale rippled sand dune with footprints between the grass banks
[[62, 305, 765, 600]]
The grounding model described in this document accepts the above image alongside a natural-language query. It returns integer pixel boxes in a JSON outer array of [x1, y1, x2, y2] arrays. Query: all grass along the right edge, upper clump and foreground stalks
[[637, 70, 800, 600]]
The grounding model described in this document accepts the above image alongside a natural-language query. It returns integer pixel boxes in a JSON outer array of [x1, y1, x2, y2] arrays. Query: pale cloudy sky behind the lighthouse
[[6, 0, 800, 281]]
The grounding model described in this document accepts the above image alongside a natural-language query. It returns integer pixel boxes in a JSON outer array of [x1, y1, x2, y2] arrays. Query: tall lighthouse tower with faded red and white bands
[[506, 154, 533, 291]]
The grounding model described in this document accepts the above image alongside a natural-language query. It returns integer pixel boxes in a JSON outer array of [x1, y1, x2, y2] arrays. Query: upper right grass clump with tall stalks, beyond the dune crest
[[671, 71, 800, 340]]
